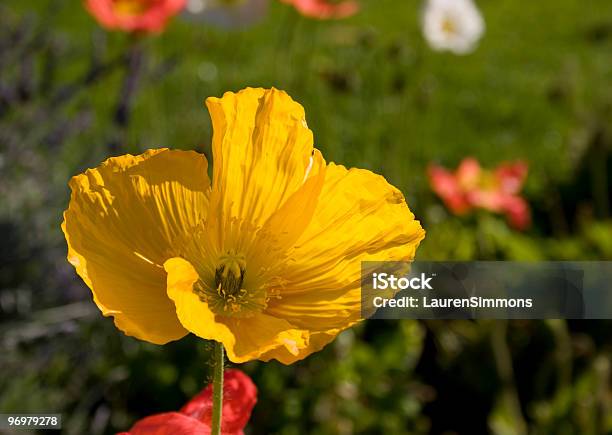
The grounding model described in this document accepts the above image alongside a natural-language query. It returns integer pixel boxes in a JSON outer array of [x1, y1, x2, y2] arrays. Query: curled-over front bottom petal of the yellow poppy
[[164, 258, 307, 363]]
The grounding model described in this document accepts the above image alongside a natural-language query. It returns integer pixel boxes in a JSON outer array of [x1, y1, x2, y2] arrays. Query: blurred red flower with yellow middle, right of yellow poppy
[[428, 158, 531, 230]]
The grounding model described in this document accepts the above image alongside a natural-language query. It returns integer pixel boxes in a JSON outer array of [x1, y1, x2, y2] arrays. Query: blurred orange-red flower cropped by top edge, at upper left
[[85, 0, 187, 32]]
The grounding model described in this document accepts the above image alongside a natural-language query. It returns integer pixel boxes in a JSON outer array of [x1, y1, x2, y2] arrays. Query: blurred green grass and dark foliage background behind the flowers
[[0, 0, 612, 435]]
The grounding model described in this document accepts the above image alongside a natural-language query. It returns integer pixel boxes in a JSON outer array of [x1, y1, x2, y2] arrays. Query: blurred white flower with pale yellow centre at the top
[[423, 0, 485, 54]]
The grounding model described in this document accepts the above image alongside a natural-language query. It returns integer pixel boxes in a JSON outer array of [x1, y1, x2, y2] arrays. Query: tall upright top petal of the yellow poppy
[[206, 88, 322, 237]]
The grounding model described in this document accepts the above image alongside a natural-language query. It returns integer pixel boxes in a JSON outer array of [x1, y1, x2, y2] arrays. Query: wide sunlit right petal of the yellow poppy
[[266, 164, 425, 331]]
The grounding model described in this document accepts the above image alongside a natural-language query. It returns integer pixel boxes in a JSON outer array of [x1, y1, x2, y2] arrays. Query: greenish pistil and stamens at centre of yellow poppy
[[194, 250, 268, 317]]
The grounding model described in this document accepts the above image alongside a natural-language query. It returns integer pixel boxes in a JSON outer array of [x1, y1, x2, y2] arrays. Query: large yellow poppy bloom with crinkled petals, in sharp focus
[[62, 88, 425, 364]]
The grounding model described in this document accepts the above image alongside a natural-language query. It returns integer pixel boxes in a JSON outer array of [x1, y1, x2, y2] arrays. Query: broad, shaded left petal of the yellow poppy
[[62, 149, 210, 344]]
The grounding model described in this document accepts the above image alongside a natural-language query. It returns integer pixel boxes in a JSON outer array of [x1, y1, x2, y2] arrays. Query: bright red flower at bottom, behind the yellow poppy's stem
[[117, 369, 257, 435]]
